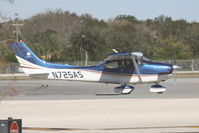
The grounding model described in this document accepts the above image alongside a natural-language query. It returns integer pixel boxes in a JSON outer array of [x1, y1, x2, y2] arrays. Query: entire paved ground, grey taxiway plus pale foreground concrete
[[0, 78, 199, 133]]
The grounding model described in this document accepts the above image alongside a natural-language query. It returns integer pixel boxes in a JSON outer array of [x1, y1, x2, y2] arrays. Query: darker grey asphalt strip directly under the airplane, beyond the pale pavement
[[0, 78, 199, 100]]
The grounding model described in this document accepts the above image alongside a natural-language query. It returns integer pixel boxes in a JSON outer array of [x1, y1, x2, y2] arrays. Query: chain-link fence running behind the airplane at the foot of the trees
[[0, 60, 199, 74]]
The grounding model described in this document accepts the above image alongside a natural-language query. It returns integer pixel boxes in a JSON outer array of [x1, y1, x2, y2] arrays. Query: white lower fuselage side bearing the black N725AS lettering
[[17, 56, 169, 84]]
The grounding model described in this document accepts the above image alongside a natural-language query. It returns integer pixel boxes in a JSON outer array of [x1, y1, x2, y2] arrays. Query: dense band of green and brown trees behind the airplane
[[0, 9, 199, 62]]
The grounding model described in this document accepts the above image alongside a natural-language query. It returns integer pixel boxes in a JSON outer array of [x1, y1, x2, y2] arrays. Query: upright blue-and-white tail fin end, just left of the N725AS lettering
[[10, 42, 46, 75]]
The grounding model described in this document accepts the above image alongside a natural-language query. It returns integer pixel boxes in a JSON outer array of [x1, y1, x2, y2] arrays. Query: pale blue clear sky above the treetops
[[0, 0, 199, 22]]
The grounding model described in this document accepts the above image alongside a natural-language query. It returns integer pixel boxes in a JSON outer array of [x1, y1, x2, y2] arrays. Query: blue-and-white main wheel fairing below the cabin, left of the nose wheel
[[114, 85, 135, 95]]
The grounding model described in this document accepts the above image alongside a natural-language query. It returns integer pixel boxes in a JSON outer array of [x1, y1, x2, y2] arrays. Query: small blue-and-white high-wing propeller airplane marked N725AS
[[10, 41, 180, 94]]
